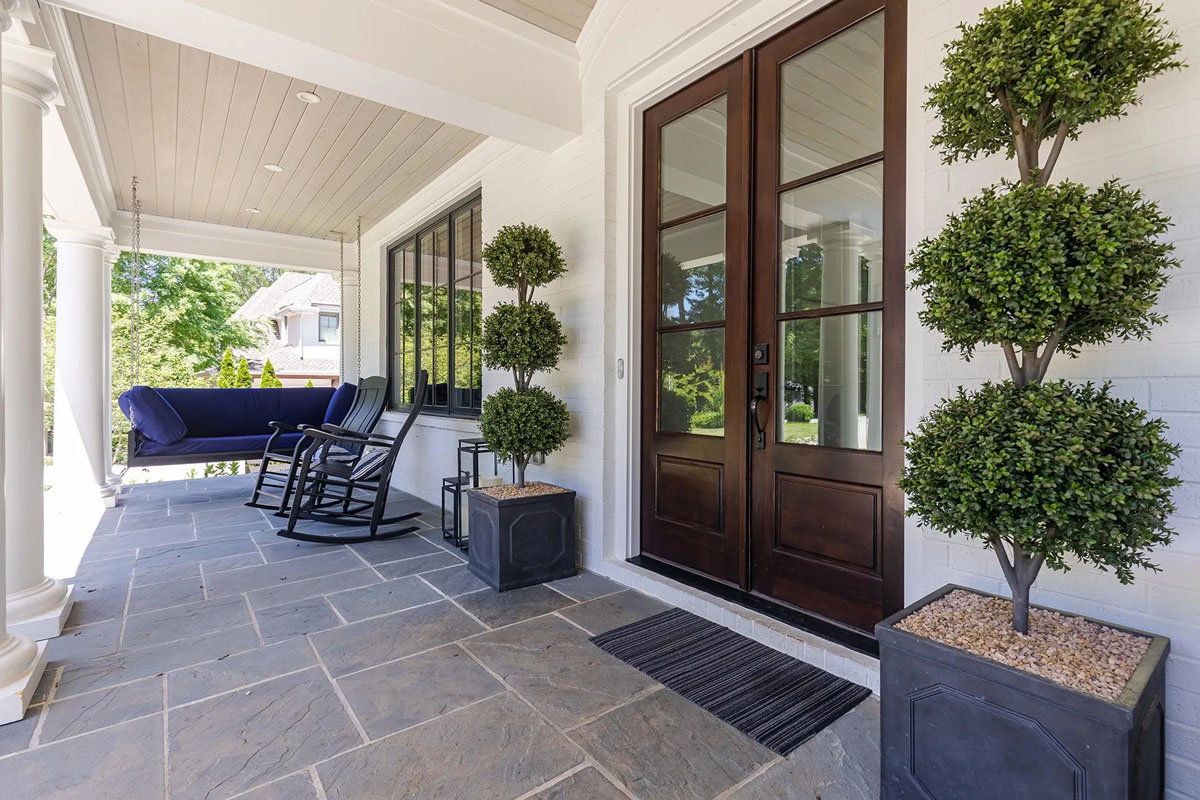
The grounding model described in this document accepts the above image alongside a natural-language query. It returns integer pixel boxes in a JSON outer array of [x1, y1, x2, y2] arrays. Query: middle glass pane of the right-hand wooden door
[[779, 163, 883, 313]]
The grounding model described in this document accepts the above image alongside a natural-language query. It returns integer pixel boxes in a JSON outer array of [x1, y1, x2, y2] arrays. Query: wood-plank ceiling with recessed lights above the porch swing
[[65, 12, 485, 239]]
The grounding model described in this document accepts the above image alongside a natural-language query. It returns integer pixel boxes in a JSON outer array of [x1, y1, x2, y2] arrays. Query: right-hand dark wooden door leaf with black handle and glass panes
[[751, 0, 905, 631]]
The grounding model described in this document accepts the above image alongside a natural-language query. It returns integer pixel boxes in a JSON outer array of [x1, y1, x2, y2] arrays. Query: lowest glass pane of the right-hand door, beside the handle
[[778, 311, 883, 451]]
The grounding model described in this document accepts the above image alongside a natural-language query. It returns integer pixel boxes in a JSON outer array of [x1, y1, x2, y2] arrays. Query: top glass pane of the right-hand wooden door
[[779, 12, 883, 184]]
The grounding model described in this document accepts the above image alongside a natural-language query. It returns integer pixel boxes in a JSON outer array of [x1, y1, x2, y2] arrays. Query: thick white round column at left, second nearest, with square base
[[0, 42, 72, 639]]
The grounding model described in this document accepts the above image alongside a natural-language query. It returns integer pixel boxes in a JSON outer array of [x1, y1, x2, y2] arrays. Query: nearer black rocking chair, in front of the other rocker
[[276, 369, 428, 545]]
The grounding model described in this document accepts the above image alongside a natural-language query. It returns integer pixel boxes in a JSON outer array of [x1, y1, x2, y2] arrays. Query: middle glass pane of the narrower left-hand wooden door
[[659, 211, 725, 325]]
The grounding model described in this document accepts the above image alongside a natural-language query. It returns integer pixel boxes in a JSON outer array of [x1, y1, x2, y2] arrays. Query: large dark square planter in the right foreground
[[875, 585, 1170, 800]]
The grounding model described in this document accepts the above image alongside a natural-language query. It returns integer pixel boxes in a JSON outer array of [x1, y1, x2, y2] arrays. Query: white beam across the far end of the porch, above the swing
[[113, 211, 345, 273]]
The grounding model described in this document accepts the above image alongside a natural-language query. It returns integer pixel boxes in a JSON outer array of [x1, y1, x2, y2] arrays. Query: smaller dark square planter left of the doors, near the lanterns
[[468, 489, 576, 591]]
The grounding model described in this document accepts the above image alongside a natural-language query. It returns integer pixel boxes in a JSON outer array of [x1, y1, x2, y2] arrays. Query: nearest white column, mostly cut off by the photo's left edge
[[0, 6, 46, 724]]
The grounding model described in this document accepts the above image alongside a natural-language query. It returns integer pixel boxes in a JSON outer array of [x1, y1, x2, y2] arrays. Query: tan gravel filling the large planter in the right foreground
[[896, 589, 1150, 700]]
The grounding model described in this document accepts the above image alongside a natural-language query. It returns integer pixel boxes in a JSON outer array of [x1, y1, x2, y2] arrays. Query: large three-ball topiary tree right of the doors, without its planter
[[900, 0, 1183, 633]]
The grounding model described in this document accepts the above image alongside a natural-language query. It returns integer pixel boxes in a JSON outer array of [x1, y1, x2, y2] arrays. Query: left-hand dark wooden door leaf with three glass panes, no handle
[[641, 54, 749, 587]]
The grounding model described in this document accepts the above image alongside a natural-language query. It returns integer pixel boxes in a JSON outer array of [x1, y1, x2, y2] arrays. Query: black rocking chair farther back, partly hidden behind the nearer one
[[246, 377, 388, 511]]
